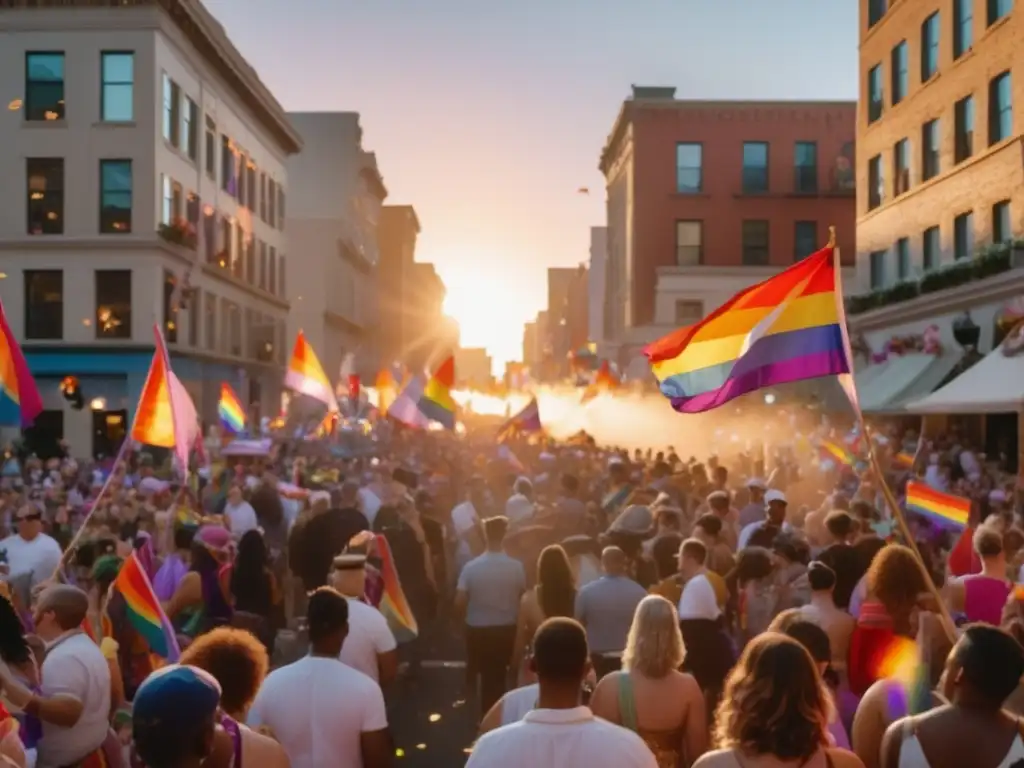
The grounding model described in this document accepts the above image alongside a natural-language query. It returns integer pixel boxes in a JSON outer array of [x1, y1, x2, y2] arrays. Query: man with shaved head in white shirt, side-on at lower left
[[0, 585, 111, 768]]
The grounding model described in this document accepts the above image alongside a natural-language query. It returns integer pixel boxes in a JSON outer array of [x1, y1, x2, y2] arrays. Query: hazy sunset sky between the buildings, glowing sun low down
[[204, 0, 857, 372]]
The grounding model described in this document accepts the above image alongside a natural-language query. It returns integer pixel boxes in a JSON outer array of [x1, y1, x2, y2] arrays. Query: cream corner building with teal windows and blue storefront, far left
[[0, 0, 301, 456]]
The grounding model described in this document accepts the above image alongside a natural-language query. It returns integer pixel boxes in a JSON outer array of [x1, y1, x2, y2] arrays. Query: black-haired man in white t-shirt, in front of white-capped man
[[249, 587, 392, 768]]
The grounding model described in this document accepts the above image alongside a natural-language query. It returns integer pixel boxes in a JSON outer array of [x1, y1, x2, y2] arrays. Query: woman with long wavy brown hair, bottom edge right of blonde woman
[[694, 632, 863, 768]]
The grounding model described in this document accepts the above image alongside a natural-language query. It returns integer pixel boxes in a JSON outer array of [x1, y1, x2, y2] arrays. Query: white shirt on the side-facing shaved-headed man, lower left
[[37, 631, 111, 768]]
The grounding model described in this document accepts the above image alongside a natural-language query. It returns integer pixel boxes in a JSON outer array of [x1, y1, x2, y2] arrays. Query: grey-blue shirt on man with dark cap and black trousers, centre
[[459, 552, 526, 627]]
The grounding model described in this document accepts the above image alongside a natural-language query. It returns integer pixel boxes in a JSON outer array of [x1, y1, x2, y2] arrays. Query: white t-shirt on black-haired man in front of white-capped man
[[249, 656, 387, 768]]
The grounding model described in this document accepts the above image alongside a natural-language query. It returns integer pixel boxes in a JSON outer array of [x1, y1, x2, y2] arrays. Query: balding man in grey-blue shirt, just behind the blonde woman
[[575, 547, 647, 678]]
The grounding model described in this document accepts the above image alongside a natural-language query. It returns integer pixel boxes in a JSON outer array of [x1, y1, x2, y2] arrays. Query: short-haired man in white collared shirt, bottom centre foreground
[[466, 618, 657, 768]]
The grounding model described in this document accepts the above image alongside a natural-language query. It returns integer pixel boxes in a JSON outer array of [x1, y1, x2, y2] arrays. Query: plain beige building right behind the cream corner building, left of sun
[[288, 112, 387, 379]]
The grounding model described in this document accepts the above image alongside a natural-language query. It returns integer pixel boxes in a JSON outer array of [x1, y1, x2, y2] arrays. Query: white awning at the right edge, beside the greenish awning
[[904, 347, 1024, 414]]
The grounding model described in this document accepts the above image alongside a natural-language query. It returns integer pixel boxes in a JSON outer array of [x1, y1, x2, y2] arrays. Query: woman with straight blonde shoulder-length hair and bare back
[[590, 595, 708, 768]]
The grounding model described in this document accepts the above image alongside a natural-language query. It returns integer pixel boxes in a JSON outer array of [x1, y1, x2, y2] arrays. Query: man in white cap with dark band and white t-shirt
[[331, 555, 398, 687]]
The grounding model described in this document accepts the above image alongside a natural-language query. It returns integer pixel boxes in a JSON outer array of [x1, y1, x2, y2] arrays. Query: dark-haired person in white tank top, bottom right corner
[[882, 624, 1024, 768]]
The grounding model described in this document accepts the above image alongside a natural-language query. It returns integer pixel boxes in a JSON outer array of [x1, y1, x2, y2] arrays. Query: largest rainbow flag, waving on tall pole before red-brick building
[[644, 247, 851, 414]]
